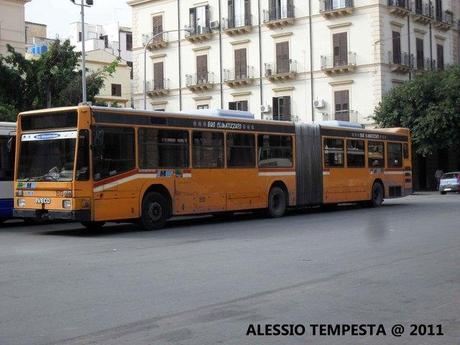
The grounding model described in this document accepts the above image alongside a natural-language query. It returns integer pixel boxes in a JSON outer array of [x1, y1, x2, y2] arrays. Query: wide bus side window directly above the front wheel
[[138, 128, 189, 169]]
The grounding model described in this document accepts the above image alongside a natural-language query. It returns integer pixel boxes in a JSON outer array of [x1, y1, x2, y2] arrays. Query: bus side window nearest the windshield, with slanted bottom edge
[[93, 127, 136, 181]]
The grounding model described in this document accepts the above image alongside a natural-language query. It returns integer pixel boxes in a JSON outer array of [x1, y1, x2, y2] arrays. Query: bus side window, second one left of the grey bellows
[[227, 133, 256, 168]]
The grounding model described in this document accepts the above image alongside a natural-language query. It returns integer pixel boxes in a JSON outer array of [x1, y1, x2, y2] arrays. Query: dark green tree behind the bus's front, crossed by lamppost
[[0, 40, 118, 121]]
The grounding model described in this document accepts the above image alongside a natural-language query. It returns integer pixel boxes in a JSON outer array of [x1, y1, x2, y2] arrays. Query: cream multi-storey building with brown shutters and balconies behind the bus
[[128, 0, 460, 125]]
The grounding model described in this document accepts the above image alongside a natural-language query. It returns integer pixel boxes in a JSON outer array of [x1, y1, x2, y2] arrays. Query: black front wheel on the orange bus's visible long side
[[141, 192, 169, 230]]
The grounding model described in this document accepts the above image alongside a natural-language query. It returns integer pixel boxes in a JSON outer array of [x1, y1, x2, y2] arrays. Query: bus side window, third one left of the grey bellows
[[192, 131, 224, 168]]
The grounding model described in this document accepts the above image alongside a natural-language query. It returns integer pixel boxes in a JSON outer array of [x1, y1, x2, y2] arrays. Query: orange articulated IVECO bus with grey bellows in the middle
[[14, 106, 412, 229]]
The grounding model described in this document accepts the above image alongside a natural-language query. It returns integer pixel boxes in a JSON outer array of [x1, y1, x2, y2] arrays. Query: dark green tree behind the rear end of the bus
[[374, 66, 460, 156]]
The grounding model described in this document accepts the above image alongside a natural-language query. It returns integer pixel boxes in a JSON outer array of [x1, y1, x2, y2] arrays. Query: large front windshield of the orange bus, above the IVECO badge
[[18, 131, 77, 182]]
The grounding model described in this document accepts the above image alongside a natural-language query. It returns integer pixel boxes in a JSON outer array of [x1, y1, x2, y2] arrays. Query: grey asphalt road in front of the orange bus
[[0, 194, 460, 345]]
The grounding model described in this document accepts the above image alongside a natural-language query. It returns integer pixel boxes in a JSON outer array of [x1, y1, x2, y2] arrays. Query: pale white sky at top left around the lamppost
[[25, 0, 131, 39]]
